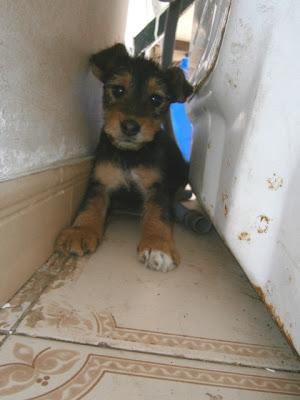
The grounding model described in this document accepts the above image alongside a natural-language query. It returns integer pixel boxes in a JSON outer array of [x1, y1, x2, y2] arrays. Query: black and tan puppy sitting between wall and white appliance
[[56, 44, 192, 272]]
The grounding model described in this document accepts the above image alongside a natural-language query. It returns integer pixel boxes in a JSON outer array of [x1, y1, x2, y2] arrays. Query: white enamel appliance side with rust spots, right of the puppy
[[189, 0, 300, 351]]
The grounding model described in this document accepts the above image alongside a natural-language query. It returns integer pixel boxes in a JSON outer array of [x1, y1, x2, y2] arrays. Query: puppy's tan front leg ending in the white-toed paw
[[138, 193, 180, 272]]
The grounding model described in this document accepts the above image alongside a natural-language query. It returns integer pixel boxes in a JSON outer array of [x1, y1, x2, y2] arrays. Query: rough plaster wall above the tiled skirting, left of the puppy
[[0, 0, 127, 180]]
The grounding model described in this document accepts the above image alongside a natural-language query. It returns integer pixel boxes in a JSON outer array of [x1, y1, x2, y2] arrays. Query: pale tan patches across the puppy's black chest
[[94, 162, 161, 192]]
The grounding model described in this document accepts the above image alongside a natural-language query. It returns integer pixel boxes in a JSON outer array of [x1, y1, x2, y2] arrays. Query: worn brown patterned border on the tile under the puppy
[[18, 302, 300, 370]]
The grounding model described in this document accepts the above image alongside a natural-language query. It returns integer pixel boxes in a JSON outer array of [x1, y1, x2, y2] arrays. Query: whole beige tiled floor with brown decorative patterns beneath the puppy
[[0, 216, 300, 400]]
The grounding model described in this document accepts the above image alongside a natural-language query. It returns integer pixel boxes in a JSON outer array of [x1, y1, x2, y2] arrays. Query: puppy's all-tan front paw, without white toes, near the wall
[[54, 226, 99, 256]]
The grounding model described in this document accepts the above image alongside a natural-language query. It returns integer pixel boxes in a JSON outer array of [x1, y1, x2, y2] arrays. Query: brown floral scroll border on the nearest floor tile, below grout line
[[0, 342, 300, 400]]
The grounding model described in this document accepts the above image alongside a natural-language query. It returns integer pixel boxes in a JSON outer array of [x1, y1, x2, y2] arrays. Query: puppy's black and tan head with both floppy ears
[[90, 44, 192, 150]]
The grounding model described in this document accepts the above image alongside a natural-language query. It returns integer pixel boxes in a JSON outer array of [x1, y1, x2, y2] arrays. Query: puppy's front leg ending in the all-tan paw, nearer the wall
[[55, 184, 108, 256]]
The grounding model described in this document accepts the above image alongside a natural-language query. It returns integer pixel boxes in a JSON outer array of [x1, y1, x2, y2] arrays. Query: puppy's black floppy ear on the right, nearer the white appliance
[[165, 67, 193, 103]]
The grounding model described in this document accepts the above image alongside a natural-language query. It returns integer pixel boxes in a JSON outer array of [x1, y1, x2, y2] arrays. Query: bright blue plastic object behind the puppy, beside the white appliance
[[170, 57, 193, 161]]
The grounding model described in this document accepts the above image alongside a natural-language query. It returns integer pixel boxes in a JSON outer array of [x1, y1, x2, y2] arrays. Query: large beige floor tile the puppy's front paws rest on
[[18, 217, 300, 370]]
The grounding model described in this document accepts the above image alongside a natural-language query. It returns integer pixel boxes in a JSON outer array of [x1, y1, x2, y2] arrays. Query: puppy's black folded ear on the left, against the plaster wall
[[90, 43, 129, 81]]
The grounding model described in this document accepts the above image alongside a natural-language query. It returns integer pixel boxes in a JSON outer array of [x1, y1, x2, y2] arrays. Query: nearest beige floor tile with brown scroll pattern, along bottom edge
[[0, 335, 300, 400]]
